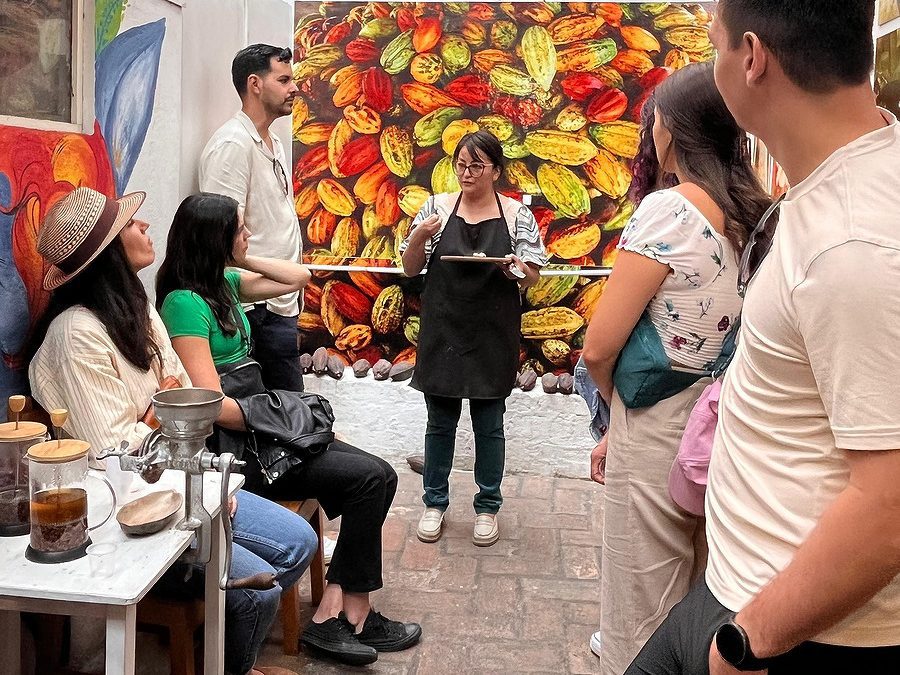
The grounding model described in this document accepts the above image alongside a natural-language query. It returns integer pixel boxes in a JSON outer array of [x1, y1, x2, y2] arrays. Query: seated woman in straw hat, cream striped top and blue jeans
[[28, 187, 316, 675]]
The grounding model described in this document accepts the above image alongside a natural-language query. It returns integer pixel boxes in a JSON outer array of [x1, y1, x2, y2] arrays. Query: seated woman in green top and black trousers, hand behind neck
[[156, 193, 422, 664]]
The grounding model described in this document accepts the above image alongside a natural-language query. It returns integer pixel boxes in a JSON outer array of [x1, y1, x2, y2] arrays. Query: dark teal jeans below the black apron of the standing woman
[[422, 394, 506, 513]]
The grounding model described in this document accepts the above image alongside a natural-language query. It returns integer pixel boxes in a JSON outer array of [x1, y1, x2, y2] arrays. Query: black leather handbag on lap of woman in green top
[[215, 357, 334, 484]]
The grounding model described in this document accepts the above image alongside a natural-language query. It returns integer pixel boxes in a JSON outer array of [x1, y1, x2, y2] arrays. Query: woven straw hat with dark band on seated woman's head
[[37, 187, 145, 291]]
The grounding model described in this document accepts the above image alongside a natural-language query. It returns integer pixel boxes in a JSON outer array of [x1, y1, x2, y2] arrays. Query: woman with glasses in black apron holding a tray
[[401, 131, 547, 546]]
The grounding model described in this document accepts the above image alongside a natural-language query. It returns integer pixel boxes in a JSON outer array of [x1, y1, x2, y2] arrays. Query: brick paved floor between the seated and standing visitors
[[260, 467, 602, 675]]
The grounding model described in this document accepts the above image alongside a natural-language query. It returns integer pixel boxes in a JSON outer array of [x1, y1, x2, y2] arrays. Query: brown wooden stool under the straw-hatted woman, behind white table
[[137, 595, 203, 675]]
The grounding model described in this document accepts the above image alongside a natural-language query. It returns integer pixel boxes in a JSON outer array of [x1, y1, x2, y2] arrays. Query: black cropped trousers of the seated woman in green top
[[258, 441, 397, 593]]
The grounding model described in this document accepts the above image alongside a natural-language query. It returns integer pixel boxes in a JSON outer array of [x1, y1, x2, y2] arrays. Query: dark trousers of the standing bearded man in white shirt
[[247, 303, 303, 391]]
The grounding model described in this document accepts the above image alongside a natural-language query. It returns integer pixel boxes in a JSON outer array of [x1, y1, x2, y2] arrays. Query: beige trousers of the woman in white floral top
[[600, 378, 711, 675]]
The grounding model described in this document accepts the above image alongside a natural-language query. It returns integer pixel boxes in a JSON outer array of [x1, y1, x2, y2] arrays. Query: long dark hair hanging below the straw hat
[[29, 237, 160, 371]]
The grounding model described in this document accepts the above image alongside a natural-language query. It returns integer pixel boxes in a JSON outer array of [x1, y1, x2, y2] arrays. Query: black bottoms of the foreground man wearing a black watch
[[625, 580, 900, 675]]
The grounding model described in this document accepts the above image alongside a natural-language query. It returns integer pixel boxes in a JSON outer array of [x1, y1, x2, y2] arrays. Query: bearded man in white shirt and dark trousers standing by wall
[[200, 44, 303, 391]]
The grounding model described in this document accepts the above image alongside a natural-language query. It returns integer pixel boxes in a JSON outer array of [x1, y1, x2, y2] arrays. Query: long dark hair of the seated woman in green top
[[156, 192, 238, 336]]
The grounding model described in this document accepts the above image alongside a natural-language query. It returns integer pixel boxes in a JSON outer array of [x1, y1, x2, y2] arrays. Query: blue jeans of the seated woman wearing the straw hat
[[225, 490, 318, 675]]
